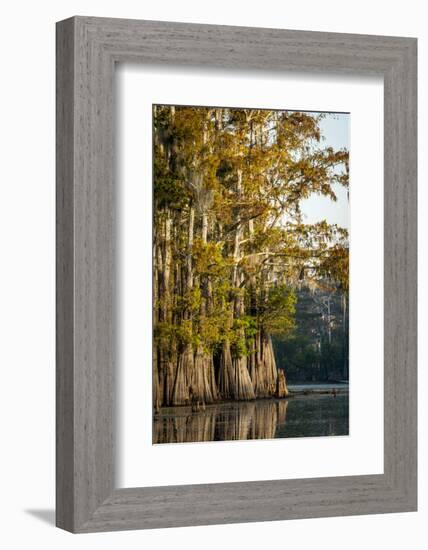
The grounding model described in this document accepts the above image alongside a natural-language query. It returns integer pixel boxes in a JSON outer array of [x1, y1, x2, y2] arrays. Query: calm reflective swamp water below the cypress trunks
[[153, 392, 349, 444]]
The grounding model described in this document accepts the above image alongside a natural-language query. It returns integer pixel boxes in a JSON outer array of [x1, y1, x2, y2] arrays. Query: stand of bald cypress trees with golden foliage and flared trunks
[[153, 106, 348, 409]]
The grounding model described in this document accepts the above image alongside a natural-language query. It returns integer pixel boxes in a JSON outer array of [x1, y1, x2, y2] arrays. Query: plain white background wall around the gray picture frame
[[0, 0, 428, 550]]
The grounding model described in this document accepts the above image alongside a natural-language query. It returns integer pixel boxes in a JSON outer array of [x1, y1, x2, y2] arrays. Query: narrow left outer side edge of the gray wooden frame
[[56, 18, 75, 530]]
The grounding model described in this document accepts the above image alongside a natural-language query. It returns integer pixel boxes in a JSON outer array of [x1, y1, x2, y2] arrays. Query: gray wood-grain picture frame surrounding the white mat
[[56, 17, 417, 532]]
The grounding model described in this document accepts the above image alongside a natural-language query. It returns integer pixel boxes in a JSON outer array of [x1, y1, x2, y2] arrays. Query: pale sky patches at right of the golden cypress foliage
[[301, 113, 351, 229]]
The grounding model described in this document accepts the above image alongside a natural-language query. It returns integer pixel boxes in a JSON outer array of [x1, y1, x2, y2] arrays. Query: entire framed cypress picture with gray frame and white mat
[[57, 17, 417, 533]]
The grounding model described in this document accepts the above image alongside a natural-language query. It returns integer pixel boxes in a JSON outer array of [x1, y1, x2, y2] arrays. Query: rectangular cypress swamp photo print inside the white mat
[[152, 105, 349, 444]]
